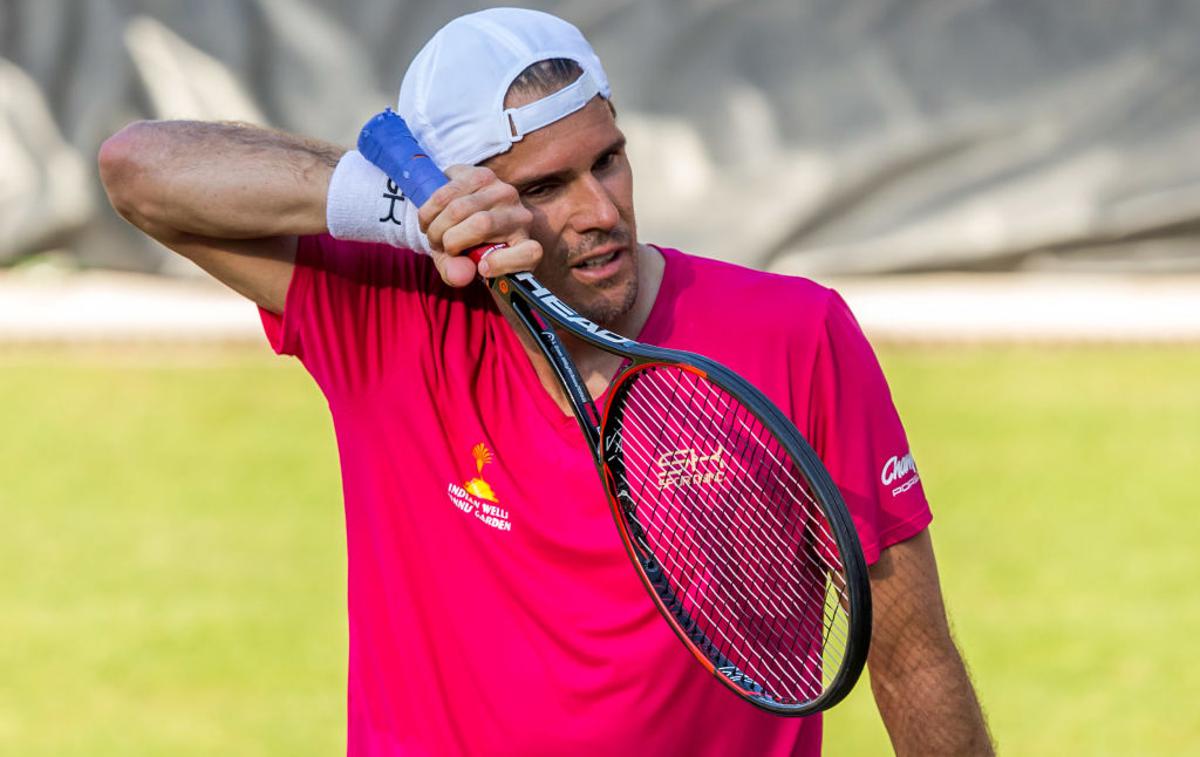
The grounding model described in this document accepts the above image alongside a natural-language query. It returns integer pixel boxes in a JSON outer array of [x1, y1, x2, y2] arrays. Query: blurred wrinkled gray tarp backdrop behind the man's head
[[0, 0, 1200, 274]]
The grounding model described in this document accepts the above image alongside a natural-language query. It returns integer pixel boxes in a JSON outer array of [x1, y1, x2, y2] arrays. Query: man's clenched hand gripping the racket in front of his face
[[420, 166, 542, 287]]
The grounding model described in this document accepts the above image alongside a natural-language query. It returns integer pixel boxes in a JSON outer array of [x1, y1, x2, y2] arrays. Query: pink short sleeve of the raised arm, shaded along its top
[[259, 234, 436, 393]]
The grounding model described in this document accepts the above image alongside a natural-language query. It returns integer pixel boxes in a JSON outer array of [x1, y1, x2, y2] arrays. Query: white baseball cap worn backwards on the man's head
[[396, 8, 612, 169]]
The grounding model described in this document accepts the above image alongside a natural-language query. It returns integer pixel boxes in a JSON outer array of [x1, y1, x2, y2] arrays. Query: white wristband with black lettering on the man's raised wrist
[[325, 150, 431, 253]]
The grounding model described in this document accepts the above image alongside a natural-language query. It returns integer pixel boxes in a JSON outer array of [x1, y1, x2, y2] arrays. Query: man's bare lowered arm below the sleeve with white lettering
[[868, 530, 992, 757]]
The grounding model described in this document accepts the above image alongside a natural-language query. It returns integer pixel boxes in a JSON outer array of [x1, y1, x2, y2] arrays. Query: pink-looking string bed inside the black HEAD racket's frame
[[609, 366, 848, 702]]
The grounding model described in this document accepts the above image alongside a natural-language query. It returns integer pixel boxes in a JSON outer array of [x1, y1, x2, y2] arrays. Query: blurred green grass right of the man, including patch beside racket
[[827, 348, 1200, 756]]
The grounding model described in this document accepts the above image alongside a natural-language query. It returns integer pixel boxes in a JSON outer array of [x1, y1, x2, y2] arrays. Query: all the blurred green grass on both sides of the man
[[0, 348, 1200, 756]]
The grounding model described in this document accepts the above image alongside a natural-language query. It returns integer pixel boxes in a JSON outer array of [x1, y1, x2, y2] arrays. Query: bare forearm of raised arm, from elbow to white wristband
[[100, 121, 344, 239]]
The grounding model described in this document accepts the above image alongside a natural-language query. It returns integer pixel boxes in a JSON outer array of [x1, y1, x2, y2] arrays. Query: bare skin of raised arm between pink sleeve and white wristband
[[100, 121, 346, 312]]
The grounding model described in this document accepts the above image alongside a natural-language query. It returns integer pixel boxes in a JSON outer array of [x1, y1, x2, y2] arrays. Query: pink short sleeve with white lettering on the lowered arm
[[809, 292, 932, 563]]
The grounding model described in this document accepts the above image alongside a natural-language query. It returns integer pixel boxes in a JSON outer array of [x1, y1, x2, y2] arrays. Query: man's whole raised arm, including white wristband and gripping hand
[[100, 121, 541, 313]]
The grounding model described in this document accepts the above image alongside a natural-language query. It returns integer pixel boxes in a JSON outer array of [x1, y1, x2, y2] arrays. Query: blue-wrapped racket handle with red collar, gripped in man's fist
[[359, 108, 504, 264]]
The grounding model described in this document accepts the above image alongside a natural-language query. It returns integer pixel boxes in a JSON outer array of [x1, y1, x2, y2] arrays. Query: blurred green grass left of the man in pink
[[0, 353, 346, 756]]
